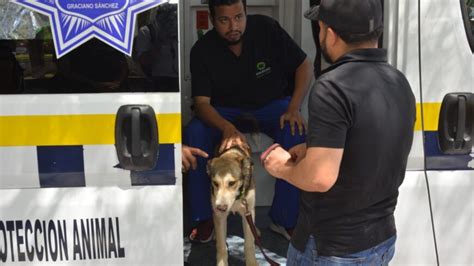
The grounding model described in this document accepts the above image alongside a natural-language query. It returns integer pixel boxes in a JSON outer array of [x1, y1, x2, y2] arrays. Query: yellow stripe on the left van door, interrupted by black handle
[[0, 114, 181, 146]]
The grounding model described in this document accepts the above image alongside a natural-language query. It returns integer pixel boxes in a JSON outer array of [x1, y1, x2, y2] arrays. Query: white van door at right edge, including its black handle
[[420, 0, 474, 265]]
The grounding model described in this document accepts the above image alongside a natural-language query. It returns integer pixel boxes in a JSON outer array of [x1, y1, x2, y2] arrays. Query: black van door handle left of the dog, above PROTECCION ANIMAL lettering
[[115, 105, 159, 171]]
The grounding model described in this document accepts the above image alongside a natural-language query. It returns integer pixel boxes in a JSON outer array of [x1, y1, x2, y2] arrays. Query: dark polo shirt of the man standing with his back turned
[[291, 49, 416, 256]]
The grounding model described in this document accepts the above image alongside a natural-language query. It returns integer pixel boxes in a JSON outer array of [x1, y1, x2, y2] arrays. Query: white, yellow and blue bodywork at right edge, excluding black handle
[[420, 0, 474, 265]]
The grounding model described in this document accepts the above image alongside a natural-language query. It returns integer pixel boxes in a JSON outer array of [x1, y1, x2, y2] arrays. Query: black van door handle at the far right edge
[[438, 93, 474, 154]]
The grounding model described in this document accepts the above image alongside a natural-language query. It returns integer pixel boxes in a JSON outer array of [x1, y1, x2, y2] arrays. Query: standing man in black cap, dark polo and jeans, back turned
[[263, 0, 415, 265]]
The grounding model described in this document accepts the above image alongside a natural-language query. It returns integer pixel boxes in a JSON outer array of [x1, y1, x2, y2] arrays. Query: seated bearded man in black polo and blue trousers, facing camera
[[183, 0, 311, 242]]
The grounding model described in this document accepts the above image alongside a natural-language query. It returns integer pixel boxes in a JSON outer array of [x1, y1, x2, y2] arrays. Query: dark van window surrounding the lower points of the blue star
[[0, 1, 179, 94]]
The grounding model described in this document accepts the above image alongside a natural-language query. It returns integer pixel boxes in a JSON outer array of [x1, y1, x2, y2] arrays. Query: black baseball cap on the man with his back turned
[[304, 0, 383, 34]]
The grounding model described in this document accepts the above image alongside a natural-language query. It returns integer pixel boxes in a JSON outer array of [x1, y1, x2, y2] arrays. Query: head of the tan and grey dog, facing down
[[207, 147, 253, 212]]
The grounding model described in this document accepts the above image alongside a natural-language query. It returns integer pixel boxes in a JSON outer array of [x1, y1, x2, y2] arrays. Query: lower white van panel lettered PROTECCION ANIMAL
[[0, 186, 183, 265]]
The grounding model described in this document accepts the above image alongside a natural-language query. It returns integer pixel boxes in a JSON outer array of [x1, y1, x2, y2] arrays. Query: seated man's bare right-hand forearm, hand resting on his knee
[[280, 58, 313, 135]]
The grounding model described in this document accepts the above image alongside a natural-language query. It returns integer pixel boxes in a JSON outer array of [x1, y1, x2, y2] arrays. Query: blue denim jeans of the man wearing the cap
[[286, 236, 397, 266]]
